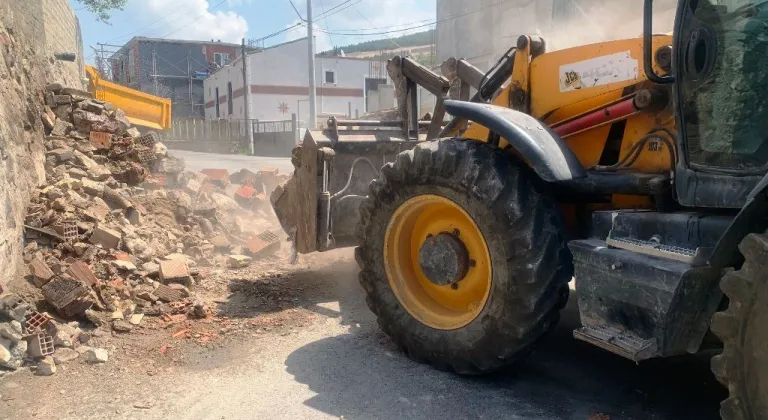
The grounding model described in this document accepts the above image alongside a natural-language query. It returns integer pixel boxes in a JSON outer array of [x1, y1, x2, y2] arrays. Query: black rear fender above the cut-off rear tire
[[709, 174, 768, 268]]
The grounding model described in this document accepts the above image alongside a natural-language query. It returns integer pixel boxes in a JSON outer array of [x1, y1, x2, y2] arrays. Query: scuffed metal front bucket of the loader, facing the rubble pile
[[271, 119, 428, 254]]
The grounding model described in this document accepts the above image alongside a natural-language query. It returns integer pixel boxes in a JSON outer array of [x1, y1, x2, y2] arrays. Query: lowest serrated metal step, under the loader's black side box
[[573, 324, 658, 362]]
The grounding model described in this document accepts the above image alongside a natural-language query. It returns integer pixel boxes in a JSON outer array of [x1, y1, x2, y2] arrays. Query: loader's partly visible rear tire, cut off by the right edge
[[712, 233, 768, 420]]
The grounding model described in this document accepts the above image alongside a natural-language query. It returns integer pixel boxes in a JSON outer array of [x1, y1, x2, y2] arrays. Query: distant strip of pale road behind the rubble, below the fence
[[170, 150, 293, 174]]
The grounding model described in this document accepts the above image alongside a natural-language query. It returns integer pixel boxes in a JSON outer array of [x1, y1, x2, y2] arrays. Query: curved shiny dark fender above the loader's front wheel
[[445, 101, 587, 182]]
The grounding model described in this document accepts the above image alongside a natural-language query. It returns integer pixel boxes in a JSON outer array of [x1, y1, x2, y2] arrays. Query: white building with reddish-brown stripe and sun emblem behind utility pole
[[203, 38, 394, 125]]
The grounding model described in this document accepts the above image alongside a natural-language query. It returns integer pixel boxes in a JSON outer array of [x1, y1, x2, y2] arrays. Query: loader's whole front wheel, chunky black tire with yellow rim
[[355, 139, 573, 374]]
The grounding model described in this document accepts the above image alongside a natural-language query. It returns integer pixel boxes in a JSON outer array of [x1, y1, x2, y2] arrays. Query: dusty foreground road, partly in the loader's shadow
[[0, 249, 724, 420]]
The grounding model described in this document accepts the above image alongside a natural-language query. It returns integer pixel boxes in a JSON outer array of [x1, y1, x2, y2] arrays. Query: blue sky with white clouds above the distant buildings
[[69, 0, 436, 63]]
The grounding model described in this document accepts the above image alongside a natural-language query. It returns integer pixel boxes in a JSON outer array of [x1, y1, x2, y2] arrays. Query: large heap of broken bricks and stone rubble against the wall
[[0, 84, 285, 375]]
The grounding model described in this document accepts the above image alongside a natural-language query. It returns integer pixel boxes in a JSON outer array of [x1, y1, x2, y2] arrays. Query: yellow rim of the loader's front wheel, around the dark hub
[[384, 194, 491, 330]]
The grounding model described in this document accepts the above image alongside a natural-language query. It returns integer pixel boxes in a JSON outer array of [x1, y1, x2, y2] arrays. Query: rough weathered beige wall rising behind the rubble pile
[[0, 0, 83, 288]]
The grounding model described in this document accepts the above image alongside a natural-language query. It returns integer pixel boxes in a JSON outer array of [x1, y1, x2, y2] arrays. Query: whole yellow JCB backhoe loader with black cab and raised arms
[[272, 0, 768, 420]]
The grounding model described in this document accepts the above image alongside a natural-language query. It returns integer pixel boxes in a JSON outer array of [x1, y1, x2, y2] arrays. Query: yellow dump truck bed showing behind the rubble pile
[[85, 66, 171, 130]]
